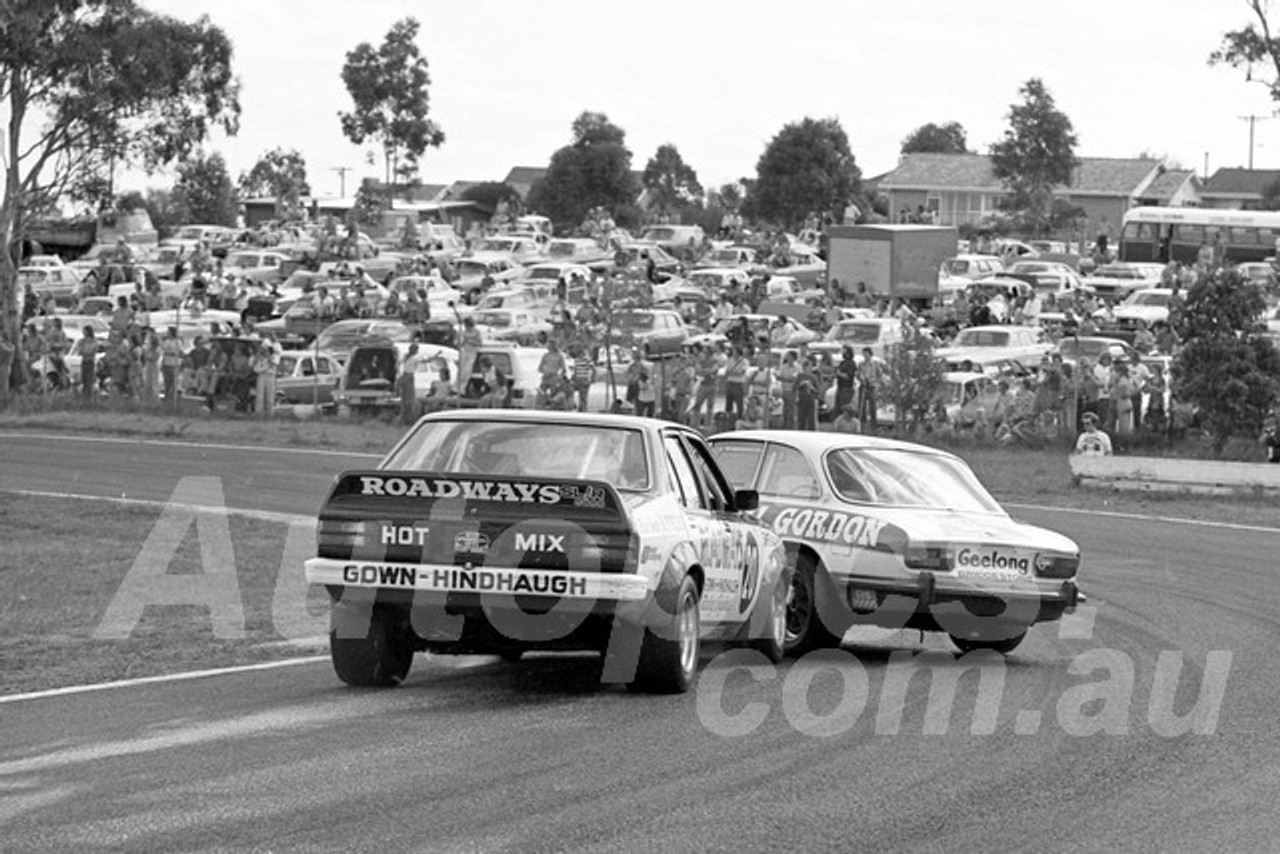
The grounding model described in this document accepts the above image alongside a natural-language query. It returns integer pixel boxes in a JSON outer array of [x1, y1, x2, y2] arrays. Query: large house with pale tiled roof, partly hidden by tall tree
[[879, 154, 1185, 230]]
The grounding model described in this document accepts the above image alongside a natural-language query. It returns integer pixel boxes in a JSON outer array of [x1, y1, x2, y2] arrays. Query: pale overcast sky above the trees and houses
[[127, 0, 1280, 196]]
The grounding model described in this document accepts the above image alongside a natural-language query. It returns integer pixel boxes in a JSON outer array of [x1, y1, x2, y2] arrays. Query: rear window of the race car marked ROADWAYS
[[381, 421, 649, 490]]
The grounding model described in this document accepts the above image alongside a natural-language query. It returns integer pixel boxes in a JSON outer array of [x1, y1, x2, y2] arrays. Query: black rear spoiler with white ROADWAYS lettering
[[329, 470, 623, 519]]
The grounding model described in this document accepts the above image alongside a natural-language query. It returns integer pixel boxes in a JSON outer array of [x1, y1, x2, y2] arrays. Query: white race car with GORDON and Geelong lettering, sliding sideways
[[710, 430, 1083, 653]]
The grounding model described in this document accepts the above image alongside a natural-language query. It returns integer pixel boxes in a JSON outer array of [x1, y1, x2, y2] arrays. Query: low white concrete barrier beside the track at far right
[[1071, 455, 1280, 494]]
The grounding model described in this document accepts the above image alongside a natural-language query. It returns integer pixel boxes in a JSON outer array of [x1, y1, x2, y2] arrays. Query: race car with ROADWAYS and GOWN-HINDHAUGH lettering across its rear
[[306, 410, 790, 693]]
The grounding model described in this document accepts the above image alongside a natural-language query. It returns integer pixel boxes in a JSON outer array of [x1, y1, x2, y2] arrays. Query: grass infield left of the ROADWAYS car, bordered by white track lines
[[0, 493, 328, 694]]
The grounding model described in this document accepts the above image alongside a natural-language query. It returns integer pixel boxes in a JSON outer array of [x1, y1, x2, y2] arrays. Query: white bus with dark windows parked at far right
[[1120, 207, 1280, 264]]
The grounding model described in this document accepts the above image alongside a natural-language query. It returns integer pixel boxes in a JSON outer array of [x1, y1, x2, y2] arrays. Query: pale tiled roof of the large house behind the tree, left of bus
[[879, 154, 1160, 196]]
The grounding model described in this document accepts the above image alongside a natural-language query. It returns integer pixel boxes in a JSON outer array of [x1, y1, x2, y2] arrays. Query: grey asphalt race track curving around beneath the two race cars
[[0, 433, 1280, 851]]
